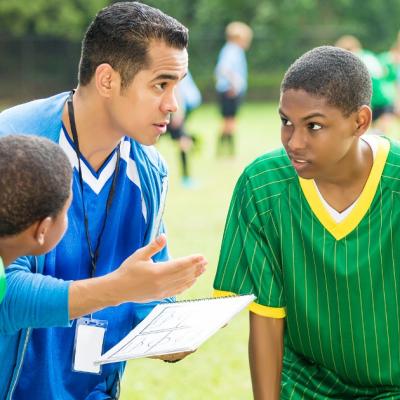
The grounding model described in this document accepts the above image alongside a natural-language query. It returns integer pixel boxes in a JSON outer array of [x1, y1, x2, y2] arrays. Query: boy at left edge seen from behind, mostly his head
[[0, 135, 72, 301]]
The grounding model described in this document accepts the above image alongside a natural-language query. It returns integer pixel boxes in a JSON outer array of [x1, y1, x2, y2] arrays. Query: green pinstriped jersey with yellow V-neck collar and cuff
[[214, 138, 400, 399]]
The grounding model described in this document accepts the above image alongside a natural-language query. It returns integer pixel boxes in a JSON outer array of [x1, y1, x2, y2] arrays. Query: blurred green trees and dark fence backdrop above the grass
[[0, 0, 400, 100]]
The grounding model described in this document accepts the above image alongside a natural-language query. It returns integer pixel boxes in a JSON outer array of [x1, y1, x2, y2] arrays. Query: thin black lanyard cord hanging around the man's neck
[[67, 91, 121, 277]]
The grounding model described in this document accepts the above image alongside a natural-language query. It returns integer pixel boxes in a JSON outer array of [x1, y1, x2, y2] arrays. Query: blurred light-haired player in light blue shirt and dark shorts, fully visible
[[215, 22, 253, 155]]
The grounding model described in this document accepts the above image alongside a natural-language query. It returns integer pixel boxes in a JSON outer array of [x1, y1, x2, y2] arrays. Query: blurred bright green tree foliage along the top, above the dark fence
[[0, 0, 400, 98]]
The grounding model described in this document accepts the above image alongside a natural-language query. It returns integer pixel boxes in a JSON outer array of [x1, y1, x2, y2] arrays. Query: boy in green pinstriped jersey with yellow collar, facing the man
[[214, 46, 400, 400]]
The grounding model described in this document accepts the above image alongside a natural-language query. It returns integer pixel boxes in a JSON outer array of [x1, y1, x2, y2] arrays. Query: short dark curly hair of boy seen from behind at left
[[0, 135, 72, 237]]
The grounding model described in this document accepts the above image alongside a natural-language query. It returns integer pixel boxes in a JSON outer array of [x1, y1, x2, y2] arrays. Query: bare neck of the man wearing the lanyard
[[62, 84, 123, 171]]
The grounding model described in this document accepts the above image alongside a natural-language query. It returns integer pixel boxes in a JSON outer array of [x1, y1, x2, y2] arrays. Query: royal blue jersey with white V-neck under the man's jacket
[[14, 131, 155, 400]]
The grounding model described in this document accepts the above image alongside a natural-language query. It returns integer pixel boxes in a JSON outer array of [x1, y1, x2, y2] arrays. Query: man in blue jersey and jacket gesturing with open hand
[[0, 2, 206, 400]]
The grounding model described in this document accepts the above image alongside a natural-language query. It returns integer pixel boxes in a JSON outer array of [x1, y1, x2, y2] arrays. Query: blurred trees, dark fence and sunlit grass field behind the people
[[0, 0, 400, 400]]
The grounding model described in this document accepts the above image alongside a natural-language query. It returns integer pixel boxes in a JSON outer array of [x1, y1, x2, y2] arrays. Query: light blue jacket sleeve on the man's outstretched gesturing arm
[[0, 257, 70, 334]]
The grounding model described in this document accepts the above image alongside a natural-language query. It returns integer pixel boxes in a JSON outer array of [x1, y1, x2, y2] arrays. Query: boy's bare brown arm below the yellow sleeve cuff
[[249, 312, 284, 400]]
